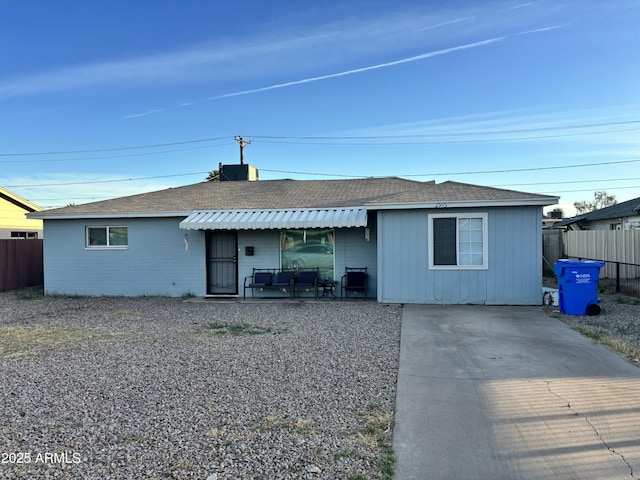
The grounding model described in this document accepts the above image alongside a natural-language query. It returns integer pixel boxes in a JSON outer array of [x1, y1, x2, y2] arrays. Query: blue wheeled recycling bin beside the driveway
[[553, 259, 604, 315]]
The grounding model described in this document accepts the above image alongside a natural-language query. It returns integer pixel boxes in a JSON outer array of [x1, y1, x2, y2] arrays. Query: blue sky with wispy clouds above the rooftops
[[0, 0, 640, 214]]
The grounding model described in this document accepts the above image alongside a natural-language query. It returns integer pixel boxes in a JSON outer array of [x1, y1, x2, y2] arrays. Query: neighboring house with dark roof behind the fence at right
[[553, 197, 640, 230]]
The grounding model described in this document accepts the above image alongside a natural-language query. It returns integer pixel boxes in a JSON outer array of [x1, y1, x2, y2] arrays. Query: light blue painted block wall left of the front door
[[44, 217, 206, 296]]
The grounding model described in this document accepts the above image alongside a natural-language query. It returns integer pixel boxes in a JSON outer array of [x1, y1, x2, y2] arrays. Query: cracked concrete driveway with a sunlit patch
[[393, 305, 640, 480]]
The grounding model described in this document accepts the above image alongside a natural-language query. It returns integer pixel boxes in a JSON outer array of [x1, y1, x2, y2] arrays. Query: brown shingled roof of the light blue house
[[30, 177, 558, 219]]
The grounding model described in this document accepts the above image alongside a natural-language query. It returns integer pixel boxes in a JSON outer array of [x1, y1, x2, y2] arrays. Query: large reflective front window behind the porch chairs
[[280, 229, 334, 280]]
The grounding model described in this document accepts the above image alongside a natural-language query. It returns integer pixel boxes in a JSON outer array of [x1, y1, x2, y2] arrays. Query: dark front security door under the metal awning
[[207, 230, 238, 295]]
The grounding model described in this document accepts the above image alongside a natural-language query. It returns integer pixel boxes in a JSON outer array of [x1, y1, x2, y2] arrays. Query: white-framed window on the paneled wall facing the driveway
[[429, 213, 488, 269]]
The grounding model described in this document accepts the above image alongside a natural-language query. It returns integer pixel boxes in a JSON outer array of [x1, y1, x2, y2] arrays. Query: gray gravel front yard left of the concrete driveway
[[0, 292, 401, 480]]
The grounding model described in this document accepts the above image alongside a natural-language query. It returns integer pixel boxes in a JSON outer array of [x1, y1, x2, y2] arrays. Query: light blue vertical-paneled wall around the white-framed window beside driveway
[[378, 207, 542, 305]]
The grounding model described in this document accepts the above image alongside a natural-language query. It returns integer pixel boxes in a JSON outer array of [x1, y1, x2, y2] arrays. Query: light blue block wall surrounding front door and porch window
[[44, 217, 376, 297]]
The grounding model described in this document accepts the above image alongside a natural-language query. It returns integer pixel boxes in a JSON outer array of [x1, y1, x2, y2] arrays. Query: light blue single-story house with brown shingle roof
[[30, 165, 558, 305]]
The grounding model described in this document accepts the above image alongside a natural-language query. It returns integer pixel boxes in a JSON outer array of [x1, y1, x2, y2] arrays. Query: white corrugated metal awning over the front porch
[[180, 207, 367, 230]]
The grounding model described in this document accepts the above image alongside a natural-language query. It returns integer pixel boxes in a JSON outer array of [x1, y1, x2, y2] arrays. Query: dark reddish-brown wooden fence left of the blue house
[[0, 239, 44, 292]]
